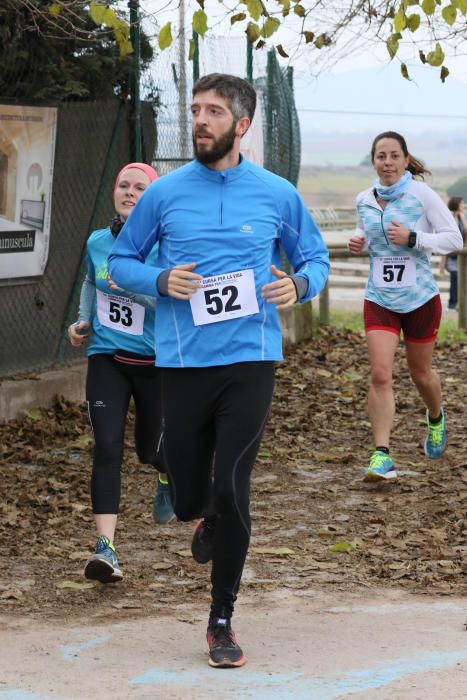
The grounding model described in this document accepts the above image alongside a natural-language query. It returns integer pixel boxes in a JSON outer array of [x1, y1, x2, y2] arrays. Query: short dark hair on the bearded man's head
[[193, 73, 256, 122]]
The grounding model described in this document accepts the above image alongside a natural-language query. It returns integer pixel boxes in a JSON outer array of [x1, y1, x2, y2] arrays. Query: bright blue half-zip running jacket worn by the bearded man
[[109, 159, 329, 367]]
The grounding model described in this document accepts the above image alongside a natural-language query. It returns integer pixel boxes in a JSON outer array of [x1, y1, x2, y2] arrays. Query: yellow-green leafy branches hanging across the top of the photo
[[7, 0, 467, 82]]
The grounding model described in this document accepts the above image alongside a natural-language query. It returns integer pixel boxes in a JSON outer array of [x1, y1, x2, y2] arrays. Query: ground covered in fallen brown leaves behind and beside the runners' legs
[[0, 329, 467, 619]]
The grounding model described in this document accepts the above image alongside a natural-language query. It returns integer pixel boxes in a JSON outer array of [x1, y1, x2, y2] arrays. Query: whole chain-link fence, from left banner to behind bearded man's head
[[0, 17, 300, 377]]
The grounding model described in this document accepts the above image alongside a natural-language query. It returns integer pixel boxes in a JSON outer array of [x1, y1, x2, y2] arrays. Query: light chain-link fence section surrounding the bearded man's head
[[149, 37, 301, 185]]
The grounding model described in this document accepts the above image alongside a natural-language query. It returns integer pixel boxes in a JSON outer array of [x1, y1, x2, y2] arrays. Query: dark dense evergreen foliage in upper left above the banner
[[0, 2, 153, 101]]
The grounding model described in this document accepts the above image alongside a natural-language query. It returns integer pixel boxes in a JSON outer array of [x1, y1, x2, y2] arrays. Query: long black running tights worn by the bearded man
[[161, 362, 274, 617]]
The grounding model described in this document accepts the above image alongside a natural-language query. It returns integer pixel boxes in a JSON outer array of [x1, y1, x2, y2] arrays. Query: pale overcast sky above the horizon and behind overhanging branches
[[141, 0, 467, 162]]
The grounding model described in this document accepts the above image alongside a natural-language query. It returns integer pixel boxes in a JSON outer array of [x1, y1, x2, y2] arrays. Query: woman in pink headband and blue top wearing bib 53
[[68, 163, 173, 583]]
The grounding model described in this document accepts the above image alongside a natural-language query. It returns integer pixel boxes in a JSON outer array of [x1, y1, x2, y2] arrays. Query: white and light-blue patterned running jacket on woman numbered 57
[[355, 180, 463, 313]]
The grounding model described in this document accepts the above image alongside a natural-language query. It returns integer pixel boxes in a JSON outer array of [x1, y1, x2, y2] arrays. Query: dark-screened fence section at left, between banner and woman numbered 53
[[0, 100, 155, 376]]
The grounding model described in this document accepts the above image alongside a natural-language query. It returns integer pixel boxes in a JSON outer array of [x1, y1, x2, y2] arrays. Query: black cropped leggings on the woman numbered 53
[[86, 355, 165, 514]]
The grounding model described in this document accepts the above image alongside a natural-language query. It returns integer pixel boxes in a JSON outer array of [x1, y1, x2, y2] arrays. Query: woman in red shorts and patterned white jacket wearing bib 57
[[348, 131, 462, 481]]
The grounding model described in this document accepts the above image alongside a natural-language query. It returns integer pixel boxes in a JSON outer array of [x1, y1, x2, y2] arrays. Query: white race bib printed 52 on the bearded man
[[190, 270, 259, 326]]
